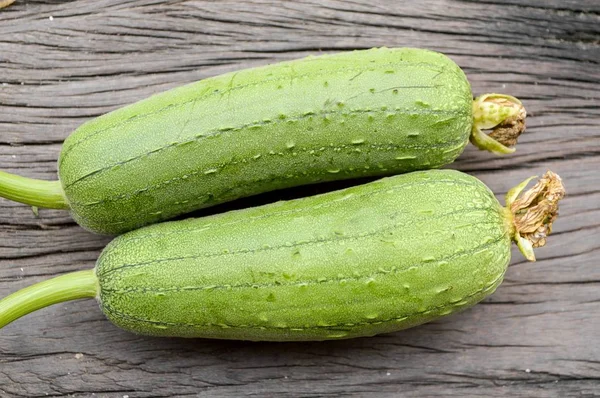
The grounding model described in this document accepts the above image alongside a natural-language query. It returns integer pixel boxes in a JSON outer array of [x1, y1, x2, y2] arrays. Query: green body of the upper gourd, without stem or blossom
[[59, 48, 472, 234]]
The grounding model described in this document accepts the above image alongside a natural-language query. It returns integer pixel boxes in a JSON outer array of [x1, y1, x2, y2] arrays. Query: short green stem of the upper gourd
[[0, 171, 69, 210]]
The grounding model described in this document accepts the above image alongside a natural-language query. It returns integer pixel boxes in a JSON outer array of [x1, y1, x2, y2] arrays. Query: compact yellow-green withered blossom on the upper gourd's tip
[[470, 94, 527, 155]]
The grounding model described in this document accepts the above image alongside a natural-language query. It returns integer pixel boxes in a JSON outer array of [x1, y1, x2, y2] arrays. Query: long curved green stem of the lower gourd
[[0, 269, 98, 329]]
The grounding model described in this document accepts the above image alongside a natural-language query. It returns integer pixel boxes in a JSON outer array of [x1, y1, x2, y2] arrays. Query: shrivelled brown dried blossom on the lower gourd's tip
[[506, 171, 565, 261]]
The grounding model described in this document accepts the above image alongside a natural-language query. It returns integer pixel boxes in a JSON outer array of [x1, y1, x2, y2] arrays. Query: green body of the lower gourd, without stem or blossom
[[96, 170, 511, 341]]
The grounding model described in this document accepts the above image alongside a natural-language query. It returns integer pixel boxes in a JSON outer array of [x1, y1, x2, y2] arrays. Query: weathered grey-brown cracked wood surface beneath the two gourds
[[0, 0, 600, 397]]
